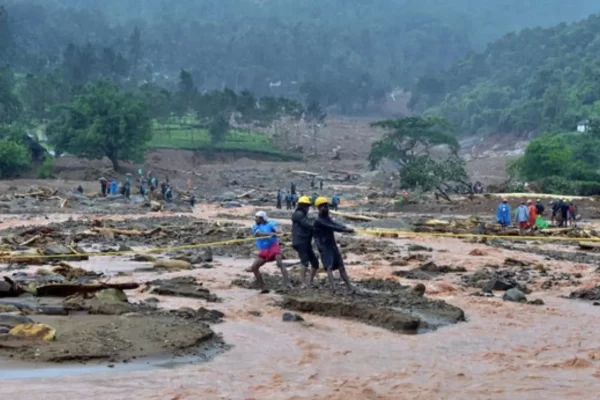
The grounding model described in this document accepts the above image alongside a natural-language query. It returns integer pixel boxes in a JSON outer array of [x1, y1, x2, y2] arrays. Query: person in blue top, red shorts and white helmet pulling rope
[[251, 211, 292, 293]]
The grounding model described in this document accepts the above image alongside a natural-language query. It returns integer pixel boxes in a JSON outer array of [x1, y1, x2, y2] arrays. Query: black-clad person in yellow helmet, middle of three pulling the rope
[[292, 196, 319, 286]]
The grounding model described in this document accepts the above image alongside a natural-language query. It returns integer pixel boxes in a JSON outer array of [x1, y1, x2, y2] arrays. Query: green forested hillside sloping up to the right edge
[[411, 15, 600, 133]]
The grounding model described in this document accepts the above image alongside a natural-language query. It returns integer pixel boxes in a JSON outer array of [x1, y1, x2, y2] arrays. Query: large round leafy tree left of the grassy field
[[48, 82, 152, 171]]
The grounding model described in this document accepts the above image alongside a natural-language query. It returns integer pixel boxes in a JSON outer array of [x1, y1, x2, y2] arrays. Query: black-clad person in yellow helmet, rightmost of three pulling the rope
[[313, 197, 356, 294]]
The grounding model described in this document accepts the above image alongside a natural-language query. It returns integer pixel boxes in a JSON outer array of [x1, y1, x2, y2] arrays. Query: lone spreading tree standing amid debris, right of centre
[[369, 117, 471, 199]]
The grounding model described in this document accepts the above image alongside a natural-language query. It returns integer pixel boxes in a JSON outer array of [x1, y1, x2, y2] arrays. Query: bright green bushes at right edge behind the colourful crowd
[[511, 122, 600, 196]]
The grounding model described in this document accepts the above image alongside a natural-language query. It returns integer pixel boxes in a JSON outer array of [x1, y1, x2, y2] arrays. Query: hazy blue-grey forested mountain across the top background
[[0, 0, 597, 113]]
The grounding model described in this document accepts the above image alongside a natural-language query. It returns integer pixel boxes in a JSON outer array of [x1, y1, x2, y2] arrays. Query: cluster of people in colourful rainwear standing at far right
[[496, 199, 578, 231]]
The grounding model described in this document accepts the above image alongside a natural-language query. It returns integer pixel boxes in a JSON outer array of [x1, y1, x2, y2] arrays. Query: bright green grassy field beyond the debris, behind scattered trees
[[148, 121, 297, 160]]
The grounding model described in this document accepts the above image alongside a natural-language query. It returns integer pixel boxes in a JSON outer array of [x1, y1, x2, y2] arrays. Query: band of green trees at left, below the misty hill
[[0, 61, 316, 174]]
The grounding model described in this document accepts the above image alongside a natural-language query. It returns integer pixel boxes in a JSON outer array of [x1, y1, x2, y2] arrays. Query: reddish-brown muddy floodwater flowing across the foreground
[[0, 209, 600, 400]]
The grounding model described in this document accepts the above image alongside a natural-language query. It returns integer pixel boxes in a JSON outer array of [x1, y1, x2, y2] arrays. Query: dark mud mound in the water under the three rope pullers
[[233, 275, 465, 333]]
